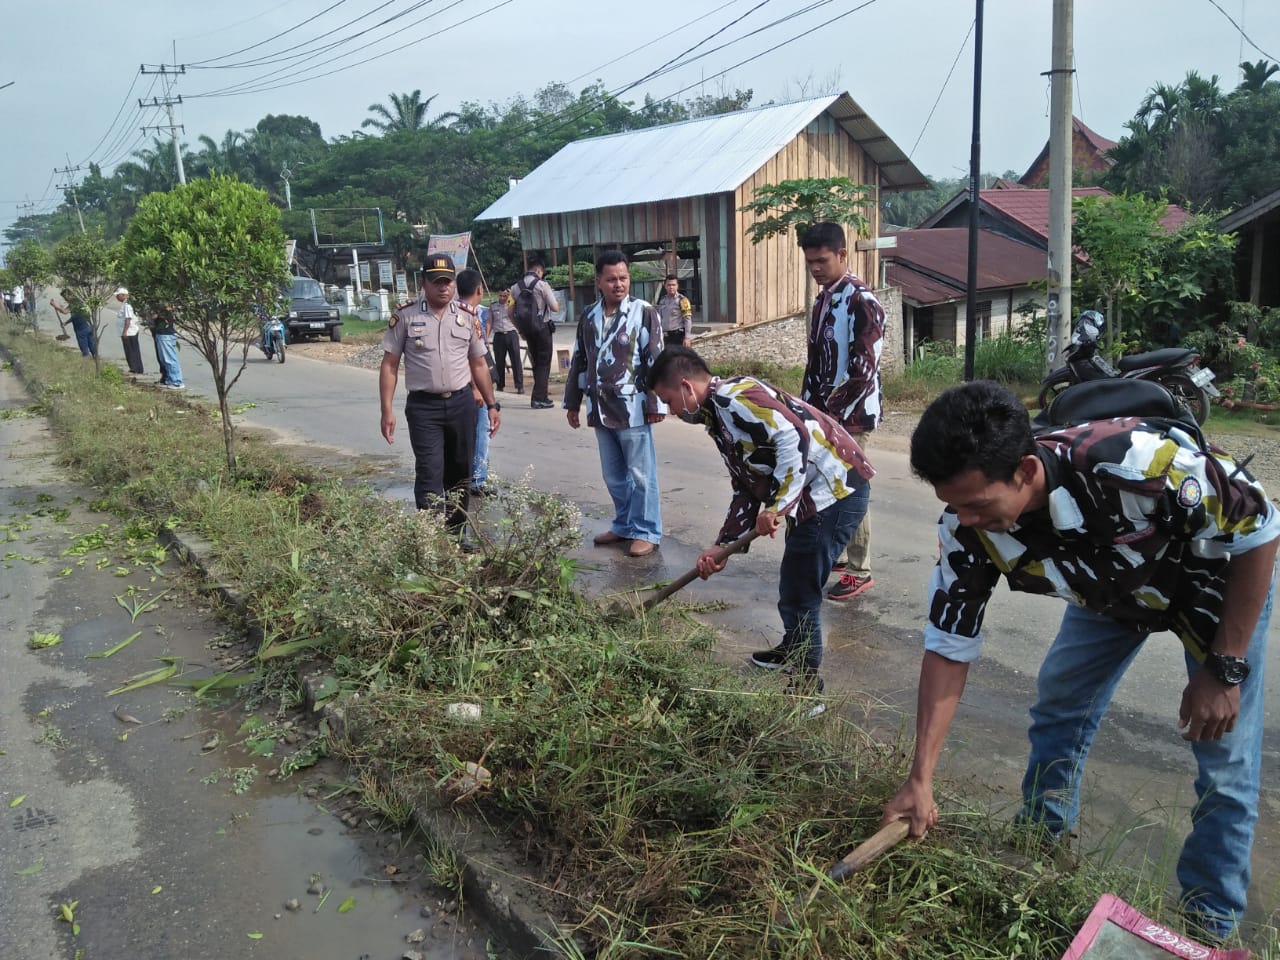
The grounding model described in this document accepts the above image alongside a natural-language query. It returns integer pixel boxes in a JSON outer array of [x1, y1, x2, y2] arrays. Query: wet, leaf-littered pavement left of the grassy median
[[0, 371, 488, 960]]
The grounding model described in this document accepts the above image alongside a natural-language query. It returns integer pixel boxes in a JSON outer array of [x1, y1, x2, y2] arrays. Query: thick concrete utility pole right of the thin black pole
[[1041, 0, 1075, 370]]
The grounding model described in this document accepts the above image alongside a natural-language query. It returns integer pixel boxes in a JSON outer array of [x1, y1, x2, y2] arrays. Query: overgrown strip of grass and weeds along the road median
[[3, 334, 1269, 960]]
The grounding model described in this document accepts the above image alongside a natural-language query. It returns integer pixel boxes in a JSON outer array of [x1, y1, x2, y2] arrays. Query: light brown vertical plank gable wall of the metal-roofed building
[[731, 114, 879, 324]]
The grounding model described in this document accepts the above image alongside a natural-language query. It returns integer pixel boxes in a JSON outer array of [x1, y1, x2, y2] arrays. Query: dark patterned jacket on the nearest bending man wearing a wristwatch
[[924, 417, 1280, 662]]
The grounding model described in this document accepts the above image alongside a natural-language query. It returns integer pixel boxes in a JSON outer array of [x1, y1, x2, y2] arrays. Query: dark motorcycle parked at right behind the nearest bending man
[[1039, 310, 1221, 425]]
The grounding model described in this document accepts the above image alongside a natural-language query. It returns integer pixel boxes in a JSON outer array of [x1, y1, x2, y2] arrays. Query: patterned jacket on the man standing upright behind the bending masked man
[[800, 273, 884, 434]]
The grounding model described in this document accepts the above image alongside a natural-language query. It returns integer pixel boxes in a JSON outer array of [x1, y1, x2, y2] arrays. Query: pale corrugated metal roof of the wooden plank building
[[476, 93, 927, 220]]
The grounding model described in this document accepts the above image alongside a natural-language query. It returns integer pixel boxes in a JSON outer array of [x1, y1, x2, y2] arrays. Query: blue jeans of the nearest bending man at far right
[[1019, 584, 1275, 937]]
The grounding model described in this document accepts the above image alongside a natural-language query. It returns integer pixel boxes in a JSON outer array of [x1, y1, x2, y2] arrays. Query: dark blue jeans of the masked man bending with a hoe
[[778, 474, 872, 673]]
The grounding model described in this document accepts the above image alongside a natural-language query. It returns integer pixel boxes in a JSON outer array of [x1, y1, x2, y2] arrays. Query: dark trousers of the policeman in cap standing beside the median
[[404, 384, 476, 530]]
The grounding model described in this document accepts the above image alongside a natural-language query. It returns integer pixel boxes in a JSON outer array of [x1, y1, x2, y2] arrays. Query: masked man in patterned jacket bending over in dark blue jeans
[[650, 347, 874, 717]]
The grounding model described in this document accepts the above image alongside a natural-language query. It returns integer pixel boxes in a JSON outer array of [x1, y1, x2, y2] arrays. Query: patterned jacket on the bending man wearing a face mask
[[700, 376, 876, 544]]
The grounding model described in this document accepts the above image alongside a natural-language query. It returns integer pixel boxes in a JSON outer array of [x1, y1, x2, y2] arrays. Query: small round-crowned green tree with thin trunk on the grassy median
[[120, 175, 288, 475]]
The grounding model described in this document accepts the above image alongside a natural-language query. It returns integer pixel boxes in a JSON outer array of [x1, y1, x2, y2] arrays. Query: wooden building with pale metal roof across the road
[[476, 93, 928, 325]]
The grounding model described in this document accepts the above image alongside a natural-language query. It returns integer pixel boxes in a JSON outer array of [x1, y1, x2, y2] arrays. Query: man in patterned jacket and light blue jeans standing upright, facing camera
[[570, 250, 666, 557]]
